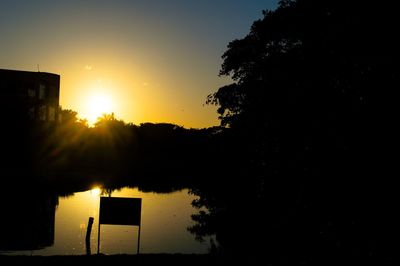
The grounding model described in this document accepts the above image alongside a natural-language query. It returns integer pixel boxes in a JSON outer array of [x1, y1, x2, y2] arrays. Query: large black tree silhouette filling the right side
[[196, 0, 398, 263]]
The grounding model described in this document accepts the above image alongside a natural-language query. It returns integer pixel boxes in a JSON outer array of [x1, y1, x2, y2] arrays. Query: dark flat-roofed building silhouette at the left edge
[[0, 69, 60, 123]]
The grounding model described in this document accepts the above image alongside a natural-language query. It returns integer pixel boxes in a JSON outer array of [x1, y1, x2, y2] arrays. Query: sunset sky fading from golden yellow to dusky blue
[[0, 0, 278, 128]]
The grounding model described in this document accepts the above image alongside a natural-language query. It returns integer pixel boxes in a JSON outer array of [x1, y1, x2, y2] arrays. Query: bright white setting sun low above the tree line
[[86, 93, 113, 125]]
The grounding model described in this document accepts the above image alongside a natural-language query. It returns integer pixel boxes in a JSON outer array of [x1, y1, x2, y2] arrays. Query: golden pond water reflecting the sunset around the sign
[[0, 188, 209, 255]]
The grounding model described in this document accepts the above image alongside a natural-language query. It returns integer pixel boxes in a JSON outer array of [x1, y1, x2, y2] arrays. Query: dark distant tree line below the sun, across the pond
[[21, 110, 222, 183]]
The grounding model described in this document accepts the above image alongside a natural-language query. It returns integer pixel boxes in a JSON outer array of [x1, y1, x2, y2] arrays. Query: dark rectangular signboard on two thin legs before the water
[[97, 197, 142, 254]]
